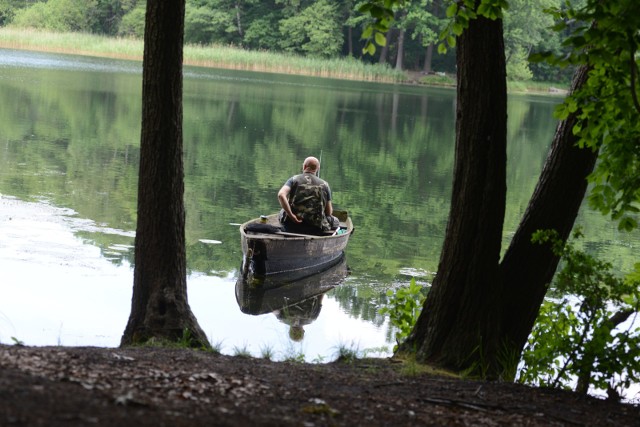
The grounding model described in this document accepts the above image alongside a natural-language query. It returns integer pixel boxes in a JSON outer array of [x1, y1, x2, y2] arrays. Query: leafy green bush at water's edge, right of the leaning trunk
[[519, 231, 640, 398]]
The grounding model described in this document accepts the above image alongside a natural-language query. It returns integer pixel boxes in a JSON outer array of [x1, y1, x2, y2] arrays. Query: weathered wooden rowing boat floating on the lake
[[240, 211, 353, 279]]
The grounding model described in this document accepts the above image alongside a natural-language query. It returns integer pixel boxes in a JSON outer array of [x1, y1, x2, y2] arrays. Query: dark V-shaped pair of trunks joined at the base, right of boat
[[400, 52, 597, 378]]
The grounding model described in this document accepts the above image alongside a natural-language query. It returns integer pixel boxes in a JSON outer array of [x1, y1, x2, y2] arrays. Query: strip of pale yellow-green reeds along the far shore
[[0, 28, 407, 83]]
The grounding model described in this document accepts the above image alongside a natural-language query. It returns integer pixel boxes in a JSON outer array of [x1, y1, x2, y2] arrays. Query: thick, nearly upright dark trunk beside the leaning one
[[400, 12, 507, 374]]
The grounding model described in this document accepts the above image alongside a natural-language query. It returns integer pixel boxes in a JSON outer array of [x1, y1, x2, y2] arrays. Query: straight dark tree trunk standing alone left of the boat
[[121, 0, 210, 347]]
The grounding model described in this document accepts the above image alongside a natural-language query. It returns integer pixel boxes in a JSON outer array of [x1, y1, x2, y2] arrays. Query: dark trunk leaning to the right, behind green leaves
[[501, 67, 598, 354]]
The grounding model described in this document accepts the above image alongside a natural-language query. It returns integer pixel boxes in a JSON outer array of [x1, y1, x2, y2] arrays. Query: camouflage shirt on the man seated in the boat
[[285, 173, 331, 230]]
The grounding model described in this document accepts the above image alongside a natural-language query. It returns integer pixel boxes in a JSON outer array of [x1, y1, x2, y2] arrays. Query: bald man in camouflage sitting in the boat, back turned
[[278, 157, 340, 235]]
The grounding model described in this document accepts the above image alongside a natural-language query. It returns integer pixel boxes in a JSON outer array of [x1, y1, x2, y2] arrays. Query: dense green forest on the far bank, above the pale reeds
[[0, 0, 584, 83]]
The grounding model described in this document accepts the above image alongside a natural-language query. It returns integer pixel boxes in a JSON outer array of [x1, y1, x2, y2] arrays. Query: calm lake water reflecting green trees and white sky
[[0, 50, 638, 361]]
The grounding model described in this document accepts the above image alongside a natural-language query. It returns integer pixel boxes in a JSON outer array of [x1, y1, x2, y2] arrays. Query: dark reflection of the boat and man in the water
[[236, 254, 348, 341]]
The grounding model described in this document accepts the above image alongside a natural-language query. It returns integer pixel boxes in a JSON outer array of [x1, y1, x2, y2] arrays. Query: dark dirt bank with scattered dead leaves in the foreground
[[0, 345, 640, 427]]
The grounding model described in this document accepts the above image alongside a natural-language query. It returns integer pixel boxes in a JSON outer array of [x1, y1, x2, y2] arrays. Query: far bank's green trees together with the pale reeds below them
[[0, 0, 570, 92]]
